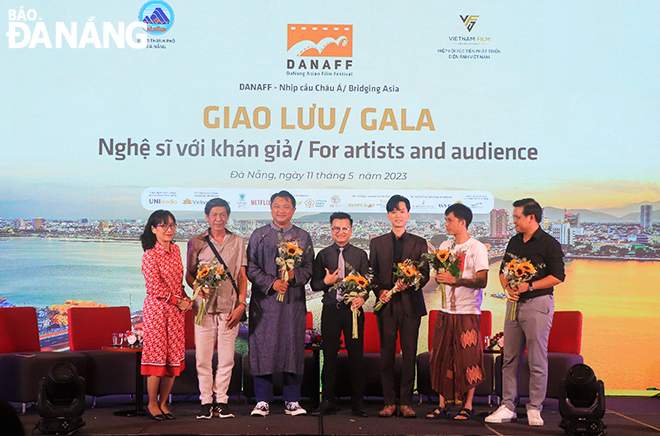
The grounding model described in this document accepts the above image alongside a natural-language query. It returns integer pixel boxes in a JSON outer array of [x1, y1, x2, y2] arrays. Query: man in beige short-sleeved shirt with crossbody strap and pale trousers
[[186, 198, 247, 419]]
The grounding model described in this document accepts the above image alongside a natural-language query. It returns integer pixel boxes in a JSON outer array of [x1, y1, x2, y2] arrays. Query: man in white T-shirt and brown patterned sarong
[[426, 203, 488, 420]]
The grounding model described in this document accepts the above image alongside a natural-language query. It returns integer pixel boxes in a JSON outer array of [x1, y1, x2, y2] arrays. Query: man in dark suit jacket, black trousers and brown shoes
[[369, 195, 429, 418]]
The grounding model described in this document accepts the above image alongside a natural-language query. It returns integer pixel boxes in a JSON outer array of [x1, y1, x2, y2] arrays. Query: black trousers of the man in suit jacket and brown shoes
[[378, 295, 422, 406]]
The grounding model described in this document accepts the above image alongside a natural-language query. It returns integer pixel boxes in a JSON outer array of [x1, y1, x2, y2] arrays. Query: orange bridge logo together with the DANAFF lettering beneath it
[[287, 24, 353, 74]]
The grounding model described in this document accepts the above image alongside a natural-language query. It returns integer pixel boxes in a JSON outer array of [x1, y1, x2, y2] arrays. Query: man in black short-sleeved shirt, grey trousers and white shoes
[[486, 198, 566, 426]]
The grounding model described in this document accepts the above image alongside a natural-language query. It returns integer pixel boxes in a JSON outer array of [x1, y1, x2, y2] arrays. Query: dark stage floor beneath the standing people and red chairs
[[15, 396, 660, 436]]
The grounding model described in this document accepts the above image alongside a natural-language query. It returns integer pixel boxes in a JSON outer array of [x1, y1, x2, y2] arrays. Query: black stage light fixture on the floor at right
[[559, 363, 607, 436]]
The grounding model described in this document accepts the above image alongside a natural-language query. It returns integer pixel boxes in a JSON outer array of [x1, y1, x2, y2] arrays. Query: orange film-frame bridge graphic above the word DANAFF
[[287, 24, 353, 58]]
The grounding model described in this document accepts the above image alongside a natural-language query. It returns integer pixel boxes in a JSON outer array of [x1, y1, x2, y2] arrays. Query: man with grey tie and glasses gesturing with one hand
[[312, 212, 369, 417]]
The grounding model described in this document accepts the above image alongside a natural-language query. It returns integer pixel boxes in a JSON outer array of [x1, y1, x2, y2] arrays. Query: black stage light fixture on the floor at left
[[36, 361, 85, 434]]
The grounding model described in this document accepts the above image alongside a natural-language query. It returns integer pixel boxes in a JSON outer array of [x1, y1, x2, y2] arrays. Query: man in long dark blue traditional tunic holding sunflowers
[[247, 191, 314, 416]]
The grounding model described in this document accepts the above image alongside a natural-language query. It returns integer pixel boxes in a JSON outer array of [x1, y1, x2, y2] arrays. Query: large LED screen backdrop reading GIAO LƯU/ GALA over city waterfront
[[0, 1, 660, 389]]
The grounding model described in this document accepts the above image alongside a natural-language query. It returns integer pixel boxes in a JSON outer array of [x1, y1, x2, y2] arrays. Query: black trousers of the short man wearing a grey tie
[[321, 302, 365, 401]]
